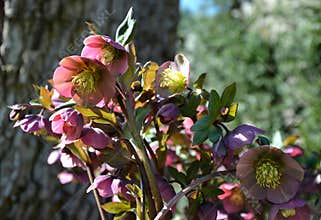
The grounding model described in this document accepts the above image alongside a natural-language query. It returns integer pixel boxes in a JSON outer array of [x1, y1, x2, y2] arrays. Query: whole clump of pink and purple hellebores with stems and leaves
[[10, 7, 321, 220]]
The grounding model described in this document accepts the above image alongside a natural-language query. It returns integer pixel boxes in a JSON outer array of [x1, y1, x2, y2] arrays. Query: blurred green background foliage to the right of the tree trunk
[[179, 0, 321, 152]]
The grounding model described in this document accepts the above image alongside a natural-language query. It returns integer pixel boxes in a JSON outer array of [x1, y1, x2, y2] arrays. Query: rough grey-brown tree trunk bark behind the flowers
[[0, 0, 178, 219]]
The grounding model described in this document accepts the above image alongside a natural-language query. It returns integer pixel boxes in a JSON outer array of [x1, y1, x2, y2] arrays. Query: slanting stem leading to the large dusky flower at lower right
[[154, 170, 233, 220]]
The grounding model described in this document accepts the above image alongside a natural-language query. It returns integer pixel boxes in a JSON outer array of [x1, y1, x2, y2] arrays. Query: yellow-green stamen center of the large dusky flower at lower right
[[255, 159, 282, 189]]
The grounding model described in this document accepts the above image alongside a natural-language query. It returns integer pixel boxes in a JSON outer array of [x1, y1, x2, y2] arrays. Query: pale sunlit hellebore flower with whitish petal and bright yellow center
[[156, 54, 190, 97]]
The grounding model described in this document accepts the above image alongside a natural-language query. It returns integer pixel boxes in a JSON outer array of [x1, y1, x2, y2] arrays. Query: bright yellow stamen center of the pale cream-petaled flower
[[160, 68, 186, 93]]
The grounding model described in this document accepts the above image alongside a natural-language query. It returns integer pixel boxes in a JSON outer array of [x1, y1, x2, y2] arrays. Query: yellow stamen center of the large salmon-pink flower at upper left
[[72, 70, 100, 95]]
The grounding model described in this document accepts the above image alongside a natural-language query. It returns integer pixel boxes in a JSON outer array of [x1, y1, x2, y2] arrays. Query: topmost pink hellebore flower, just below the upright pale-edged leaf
[[81, 35, 128, 74]]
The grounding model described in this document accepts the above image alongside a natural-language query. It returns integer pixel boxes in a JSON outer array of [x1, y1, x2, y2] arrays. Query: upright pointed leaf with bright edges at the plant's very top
[[116, 7, 136, 46]]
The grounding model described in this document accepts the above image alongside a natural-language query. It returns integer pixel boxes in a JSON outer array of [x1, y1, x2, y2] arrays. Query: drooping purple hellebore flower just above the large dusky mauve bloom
[[224, 124, 264, 150]]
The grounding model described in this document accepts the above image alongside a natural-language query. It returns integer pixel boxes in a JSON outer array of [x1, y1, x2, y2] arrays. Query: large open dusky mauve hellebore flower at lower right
[[236, 146, 304, 203]]
